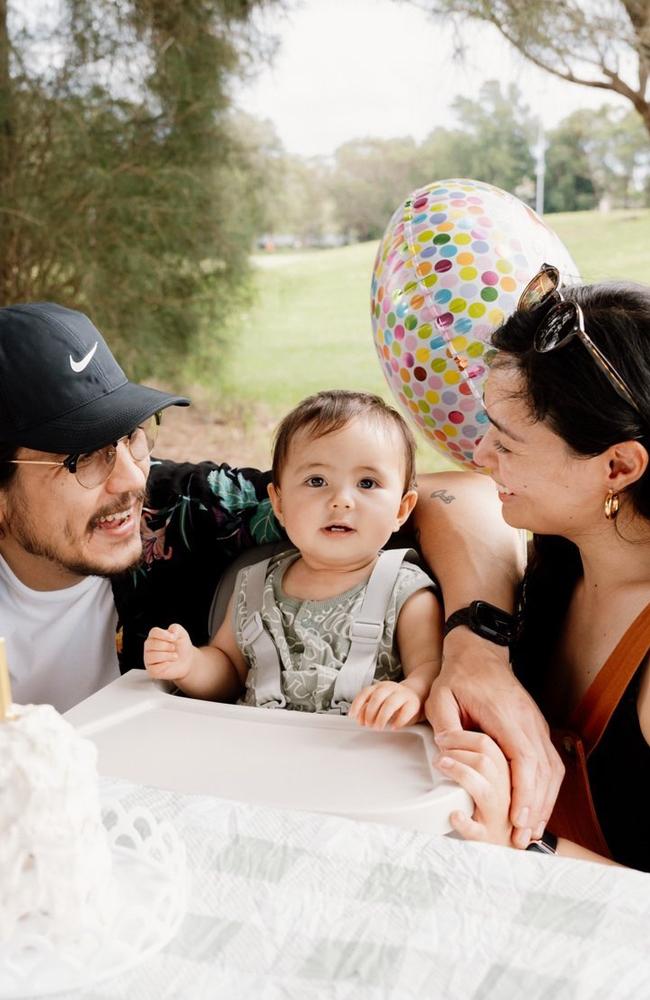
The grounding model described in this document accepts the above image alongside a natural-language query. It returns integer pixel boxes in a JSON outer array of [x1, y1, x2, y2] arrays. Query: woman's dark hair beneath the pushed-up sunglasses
[[492, 282, 650, 692]]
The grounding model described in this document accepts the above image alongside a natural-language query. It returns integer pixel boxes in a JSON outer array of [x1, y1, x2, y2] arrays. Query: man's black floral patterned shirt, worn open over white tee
[[112, 459, 283, 673]]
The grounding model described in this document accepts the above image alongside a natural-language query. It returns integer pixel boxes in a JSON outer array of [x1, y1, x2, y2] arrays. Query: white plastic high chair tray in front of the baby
[[66, 670, 472, 834]]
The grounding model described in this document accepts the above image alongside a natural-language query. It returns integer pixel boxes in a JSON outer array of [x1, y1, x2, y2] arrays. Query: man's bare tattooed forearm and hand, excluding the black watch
[[412, 472, 563, 846]]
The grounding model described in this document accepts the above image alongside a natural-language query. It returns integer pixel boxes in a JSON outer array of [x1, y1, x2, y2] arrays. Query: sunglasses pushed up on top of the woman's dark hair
[[517, 264, 642, 415]]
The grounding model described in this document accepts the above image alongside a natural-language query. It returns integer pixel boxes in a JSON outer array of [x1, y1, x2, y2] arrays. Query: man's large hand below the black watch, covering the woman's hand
[[425, 626, 564, 847]]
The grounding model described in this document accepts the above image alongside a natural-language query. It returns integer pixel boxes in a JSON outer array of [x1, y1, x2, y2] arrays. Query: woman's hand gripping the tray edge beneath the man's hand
[[435, 729, 512, 845]]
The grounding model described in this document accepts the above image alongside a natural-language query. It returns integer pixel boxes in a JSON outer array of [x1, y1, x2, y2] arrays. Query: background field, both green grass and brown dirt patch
[[156, 209, 650, 471]]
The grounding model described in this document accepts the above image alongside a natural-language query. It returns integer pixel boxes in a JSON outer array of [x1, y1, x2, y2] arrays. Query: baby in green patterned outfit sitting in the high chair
[[144, 390, 443, 729]]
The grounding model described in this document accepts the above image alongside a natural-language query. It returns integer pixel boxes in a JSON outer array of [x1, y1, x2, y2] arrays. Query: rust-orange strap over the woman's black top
[[568, 604, 650, 754]]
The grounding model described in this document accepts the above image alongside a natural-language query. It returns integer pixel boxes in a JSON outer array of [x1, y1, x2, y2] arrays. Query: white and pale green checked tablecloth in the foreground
[[41, 780, 650, 1000]]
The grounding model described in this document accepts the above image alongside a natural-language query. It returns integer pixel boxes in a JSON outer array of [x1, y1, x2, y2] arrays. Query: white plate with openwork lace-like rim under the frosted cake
[[0, 802, 187, 1000]]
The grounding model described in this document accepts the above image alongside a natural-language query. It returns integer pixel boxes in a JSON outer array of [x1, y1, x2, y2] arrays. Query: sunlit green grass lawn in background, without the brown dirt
[[222, 209, 650, 471]]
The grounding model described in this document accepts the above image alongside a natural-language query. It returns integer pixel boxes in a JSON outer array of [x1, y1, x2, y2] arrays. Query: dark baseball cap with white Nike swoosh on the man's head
[[0, 302, 189, 455]]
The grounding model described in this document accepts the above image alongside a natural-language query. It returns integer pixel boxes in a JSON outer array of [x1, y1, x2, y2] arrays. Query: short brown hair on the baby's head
[[272, 389, 415, 492]]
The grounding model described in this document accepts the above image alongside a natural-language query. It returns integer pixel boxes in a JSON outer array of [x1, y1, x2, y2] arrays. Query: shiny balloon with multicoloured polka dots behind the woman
[[371, 180, 578, 468]]
